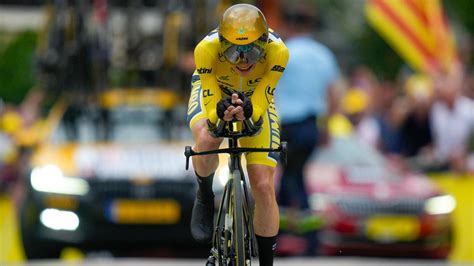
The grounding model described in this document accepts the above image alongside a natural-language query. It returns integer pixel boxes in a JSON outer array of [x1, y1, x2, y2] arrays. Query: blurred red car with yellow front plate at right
[[305, 137, 456, 258]]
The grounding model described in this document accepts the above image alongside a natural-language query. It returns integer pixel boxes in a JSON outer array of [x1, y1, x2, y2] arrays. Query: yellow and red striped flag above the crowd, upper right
[[365, 0, 457, 73]]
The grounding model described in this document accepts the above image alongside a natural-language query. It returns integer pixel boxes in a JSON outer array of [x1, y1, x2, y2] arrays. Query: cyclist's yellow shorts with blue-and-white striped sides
[[187, 75, 280, 167]]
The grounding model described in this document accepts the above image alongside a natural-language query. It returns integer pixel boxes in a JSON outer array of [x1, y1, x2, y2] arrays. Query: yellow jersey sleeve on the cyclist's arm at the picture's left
[[194, 42, 221, 124]]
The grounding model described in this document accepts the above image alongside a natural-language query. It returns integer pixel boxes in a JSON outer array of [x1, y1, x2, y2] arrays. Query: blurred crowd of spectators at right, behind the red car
[[329, 62, 474, 174]]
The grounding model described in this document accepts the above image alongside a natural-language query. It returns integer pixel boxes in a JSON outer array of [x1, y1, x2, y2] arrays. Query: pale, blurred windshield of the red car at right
[[316, 137, 399, 183]]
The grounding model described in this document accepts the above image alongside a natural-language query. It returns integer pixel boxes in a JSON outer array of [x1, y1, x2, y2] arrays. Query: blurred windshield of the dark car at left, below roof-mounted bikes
[[51, 102, 190, 144]]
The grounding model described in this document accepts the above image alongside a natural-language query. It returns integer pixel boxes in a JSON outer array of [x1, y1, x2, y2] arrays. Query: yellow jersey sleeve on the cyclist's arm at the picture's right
[[251, 42, 289, 121]]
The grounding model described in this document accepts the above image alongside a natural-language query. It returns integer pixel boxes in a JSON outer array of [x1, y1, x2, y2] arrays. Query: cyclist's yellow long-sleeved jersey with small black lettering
[[194, 30, 289, 123]]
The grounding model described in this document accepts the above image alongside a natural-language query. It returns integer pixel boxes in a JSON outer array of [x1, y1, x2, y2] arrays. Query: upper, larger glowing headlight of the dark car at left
[[30, 164, 89, 196]]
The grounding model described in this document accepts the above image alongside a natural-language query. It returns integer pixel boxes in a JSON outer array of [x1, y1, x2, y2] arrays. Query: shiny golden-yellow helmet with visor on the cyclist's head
[[219, 4, 268, 64]]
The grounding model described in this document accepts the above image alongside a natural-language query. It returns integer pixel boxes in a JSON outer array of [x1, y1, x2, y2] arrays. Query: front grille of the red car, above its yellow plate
[[337, 198, 424, 216]]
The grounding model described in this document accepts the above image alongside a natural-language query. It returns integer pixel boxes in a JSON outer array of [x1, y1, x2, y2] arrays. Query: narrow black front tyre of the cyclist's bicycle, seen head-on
[[232, 170, 246, 266]]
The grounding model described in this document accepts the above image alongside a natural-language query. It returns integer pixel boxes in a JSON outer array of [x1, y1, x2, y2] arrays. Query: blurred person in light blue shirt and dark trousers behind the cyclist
[[275, 1, 339, 254]]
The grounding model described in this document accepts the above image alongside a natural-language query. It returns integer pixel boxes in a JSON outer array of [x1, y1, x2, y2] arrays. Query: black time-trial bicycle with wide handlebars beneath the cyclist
[[184, 121, 286, 266]]
